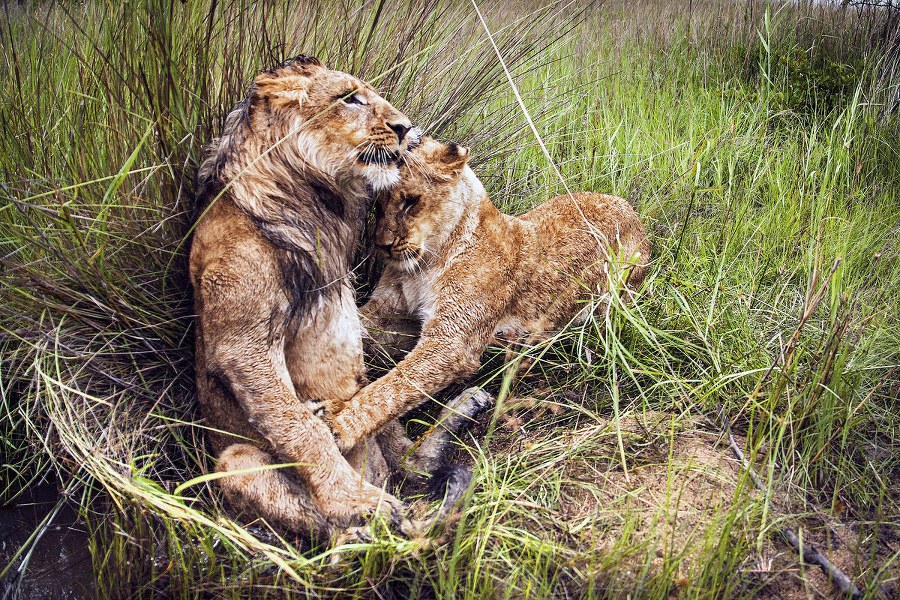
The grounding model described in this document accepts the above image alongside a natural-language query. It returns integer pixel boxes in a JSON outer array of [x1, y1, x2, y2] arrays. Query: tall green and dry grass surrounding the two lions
[[0, 0, 900, 598]]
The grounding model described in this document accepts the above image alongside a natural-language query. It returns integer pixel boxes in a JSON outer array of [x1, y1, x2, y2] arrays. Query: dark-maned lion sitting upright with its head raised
[[190, 56, 478, 539]]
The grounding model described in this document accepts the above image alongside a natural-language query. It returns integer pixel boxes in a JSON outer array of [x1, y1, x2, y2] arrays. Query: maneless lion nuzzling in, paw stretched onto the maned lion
[[334, 138, 650, 448]]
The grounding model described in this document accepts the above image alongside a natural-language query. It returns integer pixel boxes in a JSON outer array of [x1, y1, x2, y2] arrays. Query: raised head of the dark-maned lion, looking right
[[246, 56, 421, 190]]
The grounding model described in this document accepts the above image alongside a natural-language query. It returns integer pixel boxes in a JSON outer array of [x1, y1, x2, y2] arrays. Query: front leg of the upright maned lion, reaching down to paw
[[201, 274, 403, 524]]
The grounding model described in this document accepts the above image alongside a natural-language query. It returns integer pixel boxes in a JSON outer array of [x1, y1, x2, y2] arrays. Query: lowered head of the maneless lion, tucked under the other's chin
[[375, 137, 474, 272]]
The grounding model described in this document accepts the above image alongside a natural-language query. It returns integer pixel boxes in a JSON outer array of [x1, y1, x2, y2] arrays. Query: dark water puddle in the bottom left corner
[[0, 484, 95, 600]]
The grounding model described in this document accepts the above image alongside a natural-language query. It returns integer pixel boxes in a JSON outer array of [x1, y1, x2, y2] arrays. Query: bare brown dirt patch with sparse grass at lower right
[[474, 398, 900, 600]]
